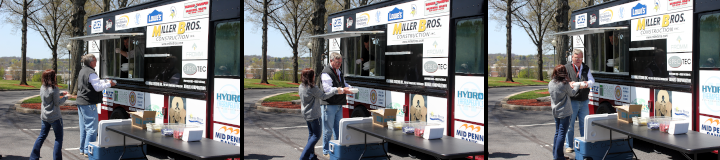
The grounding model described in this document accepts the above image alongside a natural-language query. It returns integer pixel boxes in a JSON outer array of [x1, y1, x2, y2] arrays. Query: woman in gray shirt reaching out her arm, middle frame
[[298, 68, 349, 160]]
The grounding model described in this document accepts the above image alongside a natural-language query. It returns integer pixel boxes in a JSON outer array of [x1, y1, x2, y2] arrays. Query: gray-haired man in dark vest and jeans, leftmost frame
[[76, 54, 115, 157]]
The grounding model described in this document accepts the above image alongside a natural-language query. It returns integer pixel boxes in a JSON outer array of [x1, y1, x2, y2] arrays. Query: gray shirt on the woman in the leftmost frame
[[40, 85, 68, 123]]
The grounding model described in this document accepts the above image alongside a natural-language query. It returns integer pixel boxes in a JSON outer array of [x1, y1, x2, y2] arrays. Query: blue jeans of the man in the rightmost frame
[[565, 100, 590, 148]]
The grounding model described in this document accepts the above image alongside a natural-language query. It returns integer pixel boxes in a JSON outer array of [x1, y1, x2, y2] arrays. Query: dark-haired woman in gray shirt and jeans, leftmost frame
[[30, 69, 68, 160]]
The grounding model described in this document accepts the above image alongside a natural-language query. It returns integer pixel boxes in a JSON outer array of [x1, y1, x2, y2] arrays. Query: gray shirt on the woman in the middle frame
[[298, 84, 337, 121]]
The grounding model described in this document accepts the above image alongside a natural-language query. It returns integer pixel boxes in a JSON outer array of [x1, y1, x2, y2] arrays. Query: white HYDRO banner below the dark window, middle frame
[[453, 76, 485, 123]]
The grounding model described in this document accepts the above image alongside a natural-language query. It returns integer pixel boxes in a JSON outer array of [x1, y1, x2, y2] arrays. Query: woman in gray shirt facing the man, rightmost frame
[[548, 65, 580, 160]]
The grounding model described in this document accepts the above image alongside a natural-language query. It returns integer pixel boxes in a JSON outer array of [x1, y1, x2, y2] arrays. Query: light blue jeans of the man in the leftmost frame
[[78, 104, 98, 154]]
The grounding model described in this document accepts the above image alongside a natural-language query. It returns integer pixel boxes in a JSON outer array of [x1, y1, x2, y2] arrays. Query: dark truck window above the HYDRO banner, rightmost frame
[[694, 13, 720, 68]]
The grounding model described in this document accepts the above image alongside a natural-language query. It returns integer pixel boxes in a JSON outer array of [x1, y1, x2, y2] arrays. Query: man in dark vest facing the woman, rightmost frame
[[565, 49, 595, 153]]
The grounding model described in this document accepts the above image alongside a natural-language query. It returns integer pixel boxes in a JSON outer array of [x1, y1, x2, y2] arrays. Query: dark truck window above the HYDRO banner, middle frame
[[455, 18, 485, 74]]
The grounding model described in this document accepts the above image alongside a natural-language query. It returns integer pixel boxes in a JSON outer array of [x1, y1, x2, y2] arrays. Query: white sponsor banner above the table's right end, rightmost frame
[[660, 91, 693, 130]]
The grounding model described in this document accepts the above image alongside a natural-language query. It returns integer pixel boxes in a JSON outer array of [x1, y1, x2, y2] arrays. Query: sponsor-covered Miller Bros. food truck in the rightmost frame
[[557, 0, 720, 136]]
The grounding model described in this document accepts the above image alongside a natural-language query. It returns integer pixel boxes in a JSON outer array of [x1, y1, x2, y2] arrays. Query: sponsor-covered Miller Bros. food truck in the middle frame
[[311, 0, 487, 149]]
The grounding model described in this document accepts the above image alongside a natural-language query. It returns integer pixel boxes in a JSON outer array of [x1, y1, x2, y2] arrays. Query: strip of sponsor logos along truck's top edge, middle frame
[[352, 0, 450, 31]]
